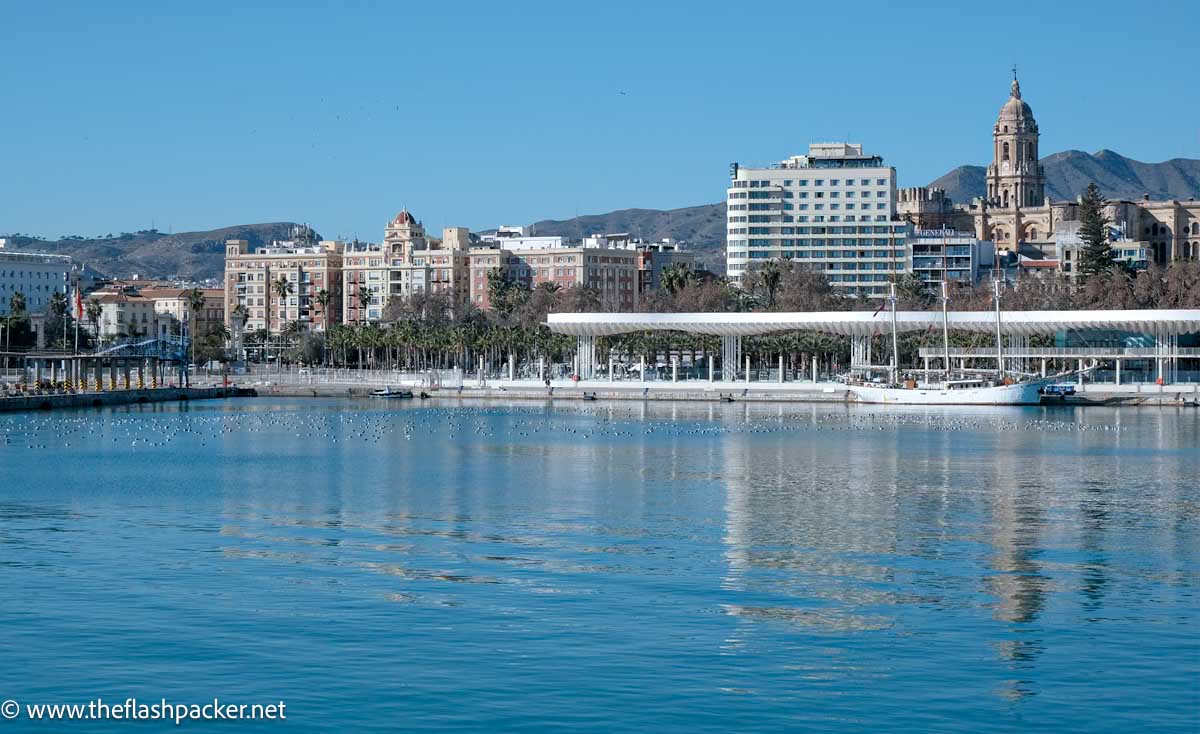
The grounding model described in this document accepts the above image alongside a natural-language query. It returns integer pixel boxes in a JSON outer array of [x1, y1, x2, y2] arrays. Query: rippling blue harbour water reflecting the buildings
[[0, 398, 1200, 733]]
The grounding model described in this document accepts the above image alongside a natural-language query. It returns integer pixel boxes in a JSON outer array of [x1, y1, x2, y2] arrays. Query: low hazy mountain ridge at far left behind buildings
[[6, 222, 309, 281]]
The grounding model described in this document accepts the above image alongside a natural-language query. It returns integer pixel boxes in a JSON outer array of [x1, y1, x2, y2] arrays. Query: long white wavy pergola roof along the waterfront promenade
[[546, 308, 1200, 336]]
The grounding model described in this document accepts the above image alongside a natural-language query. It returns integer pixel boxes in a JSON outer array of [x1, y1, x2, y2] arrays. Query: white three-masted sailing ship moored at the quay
[[846, 281, 1062, 405]]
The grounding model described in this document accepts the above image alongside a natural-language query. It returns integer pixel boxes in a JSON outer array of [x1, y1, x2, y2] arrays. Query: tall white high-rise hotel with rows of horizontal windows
[[726, 143, 911, 297]]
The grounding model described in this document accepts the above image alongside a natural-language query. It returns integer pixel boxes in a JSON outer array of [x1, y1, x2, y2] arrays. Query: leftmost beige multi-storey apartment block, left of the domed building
[[224, 228, 346, 333]]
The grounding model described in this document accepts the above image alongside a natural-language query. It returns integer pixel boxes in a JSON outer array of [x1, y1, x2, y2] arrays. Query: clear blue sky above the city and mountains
[[0, 0, 1200, 240]]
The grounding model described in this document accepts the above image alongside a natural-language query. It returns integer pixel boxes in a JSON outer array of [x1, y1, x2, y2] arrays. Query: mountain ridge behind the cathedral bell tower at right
[[929, 150, 1200, 204]]
